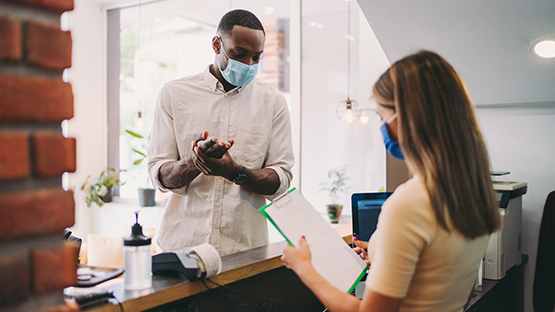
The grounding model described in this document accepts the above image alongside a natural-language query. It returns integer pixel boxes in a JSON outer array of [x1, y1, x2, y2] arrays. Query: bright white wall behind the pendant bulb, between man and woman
[[301, 0, 389, 215]]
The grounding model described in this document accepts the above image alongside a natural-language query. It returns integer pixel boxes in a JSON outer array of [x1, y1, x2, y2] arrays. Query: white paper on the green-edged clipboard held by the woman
[[264, 190, 366, 292]]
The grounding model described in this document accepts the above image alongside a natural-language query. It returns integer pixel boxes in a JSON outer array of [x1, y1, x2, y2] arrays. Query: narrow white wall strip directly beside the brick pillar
[[67, 0, 106, 238]]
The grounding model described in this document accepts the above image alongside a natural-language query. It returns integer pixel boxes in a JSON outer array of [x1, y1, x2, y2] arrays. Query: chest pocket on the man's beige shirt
[[230, 123, 270, 169]]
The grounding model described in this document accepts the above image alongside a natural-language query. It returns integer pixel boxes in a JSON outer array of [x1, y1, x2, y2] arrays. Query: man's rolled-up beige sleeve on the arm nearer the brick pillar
[[147, 86, 187, 195]]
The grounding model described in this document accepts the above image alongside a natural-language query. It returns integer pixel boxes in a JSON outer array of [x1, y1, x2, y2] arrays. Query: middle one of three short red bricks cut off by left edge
[[0, 132, 30, 180]]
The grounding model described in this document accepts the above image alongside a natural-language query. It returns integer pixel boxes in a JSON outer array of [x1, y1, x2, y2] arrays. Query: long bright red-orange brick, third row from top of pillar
[[0, 73, 73, 122]]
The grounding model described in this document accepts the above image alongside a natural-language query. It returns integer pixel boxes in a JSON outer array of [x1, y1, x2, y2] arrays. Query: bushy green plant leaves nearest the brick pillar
[[81, 168, 125, 207]]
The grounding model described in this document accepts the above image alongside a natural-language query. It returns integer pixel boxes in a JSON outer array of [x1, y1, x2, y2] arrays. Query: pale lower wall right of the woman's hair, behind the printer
[[471, 105, 555, 312]]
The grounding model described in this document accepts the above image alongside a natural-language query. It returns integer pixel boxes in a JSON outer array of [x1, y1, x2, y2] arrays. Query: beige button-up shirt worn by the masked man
[[148, 66, 294, 255]]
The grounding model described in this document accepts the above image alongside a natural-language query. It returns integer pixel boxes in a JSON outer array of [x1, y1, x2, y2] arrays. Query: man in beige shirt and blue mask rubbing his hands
[[148, 10, 294, 255]]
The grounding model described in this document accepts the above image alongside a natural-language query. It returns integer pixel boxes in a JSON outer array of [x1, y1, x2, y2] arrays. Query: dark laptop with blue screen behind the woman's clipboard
[[351, 192, 393, 298]]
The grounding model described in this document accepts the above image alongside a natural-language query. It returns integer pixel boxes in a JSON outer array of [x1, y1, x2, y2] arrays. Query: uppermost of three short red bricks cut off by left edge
[[0, 16, 21, 61]]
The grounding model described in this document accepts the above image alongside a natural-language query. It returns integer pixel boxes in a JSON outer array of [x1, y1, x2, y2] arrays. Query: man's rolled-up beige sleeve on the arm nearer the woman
[[264, 94, 295, 200]]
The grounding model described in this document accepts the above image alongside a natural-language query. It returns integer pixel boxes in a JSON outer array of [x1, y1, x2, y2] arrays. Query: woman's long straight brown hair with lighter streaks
[[373, 51, 501, 238]]
